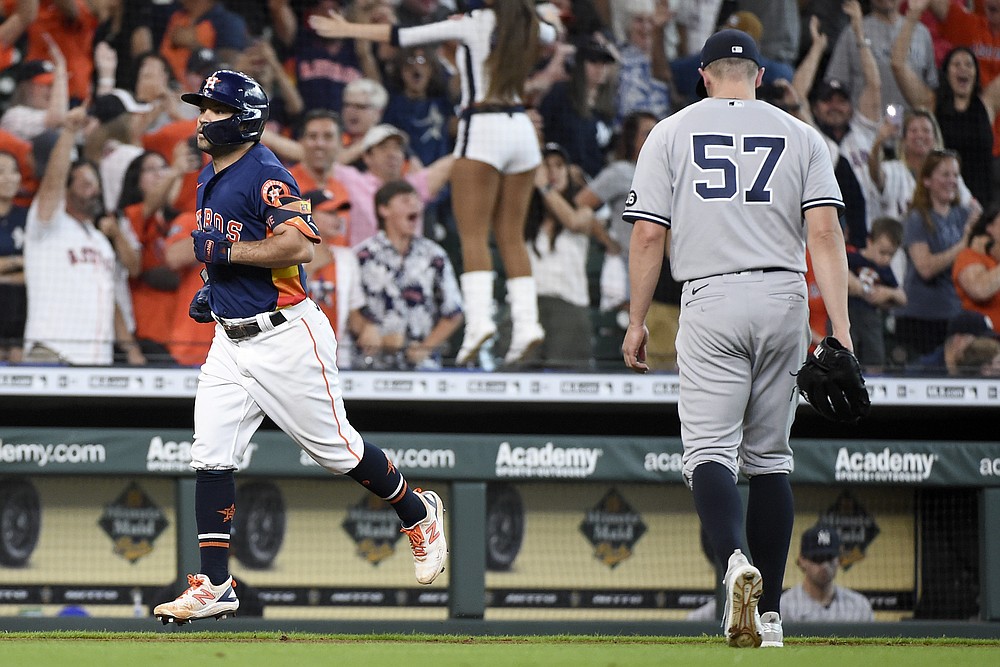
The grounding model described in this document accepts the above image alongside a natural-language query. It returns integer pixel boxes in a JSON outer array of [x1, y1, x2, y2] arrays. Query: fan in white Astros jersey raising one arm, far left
[[24, 107, 136, 366]]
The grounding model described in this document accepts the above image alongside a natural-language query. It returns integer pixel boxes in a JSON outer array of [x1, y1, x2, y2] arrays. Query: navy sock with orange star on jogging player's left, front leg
[[194, 470, 236, 586]]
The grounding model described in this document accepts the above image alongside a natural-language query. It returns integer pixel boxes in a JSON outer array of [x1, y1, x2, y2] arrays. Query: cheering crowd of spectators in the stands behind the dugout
[[0, 0, 1000, 376]]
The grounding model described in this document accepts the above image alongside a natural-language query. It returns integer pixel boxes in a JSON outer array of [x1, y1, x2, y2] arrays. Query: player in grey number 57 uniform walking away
[[622, 30, 851, 647]]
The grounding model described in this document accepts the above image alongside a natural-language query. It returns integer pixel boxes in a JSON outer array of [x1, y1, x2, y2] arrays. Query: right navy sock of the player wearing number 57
[[747, 473, 795, 614]]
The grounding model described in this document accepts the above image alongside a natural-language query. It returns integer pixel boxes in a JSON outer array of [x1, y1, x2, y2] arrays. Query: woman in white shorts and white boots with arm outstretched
[[309, 0, 556, 365]]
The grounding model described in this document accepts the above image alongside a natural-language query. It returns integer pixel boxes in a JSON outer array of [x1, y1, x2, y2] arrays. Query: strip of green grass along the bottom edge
[[0, 632, 1000, 667]]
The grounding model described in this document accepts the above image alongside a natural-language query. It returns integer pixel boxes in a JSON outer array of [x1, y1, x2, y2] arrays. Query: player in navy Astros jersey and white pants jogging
[[153, 70, 447, 624]]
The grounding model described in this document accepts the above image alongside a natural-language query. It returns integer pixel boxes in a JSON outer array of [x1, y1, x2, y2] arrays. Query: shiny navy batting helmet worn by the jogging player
[[181, 69, 268, 146]]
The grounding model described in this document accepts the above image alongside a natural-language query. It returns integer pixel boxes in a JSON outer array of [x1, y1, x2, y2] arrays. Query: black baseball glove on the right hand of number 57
[[795, 336, 871, 424]]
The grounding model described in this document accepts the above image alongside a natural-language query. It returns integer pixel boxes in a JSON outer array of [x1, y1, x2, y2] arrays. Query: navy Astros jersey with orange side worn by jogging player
[[197, 144, 320, 319]]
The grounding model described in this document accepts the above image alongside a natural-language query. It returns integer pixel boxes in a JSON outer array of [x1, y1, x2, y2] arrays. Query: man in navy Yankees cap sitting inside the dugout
[[781, 523, 875, 623]]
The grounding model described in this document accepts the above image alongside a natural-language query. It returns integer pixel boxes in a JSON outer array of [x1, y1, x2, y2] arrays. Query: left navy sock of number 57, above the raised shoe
[[691, 461, 743, 570]]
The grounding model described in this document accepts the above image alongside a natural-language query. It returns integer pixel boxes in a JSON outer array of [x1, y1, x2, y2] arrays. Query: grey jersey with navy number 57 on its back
[[622, 98, 844, 281]]
